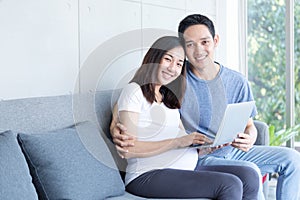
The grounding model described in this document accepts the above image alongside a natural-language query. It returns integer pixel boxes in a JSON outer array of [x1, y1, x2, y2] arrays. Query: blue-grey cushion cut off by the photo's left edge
[[0, 131, 38, 200]]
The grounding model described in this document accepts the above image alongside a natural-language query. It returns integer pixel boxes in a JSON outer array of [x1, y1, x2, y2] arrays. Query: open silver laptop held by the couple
[[193, 101, 255, 148]]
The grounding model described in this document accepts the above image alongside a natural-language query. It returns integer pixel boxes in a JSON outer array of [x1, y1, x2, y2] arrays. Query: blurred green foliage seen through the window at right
[[248, 0, 300, 145]]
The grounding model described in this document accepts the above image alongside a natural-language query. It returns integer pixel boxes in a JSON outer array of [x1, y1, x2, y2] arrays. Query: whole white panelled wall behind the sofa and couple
[[0, 0, 237, 99]]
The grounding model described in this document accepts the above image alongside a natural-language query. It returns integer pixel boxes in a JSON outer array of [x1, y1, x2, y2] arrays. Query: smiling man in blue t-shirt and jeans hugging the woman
[[111, 14, 300, 200]]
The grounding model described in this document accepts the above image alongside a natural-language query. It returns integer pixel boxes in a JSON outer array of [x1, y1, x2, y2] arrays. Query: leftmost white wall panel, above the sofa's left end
[[0, 0, 78, 99]]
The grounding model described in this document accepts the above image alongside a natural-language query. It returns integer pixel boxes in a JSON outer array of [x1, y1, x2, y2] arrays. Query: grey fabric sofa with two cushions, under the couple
[[0, 90, 269, 200]]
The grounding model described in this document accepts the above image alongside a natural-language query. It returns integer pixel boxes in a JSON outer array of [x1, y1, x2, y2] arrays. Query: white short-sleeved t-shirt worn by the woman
[[118, 83, 198, 185]]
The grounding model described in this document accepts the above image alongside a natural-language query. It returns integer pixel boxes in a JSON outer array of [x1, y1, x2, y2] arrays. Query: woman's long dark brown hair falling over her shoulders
[[130, 36, 186, 109]]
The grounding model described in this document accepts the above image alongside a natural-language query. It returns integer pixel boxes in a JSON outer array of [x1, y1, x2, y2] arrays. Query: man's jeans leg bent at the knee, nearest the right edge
[[229, 146, 300, 200]]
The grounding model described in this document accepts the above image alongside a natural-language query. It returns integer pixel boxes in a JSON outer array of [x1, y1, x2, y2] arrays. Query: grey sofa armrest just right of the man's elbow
[[254, 120, 269, 146]]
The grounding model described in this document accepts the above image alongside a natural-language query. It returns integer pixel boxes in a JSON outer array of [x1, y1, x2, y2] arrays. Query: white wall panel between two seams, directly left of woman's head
[[80, 0, 141, 92]]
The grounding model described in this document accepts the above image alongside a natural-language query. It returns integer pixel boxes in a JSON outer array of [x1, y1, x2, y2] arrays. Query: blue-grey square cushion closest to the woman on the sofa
[[18, 122, 124, 200]]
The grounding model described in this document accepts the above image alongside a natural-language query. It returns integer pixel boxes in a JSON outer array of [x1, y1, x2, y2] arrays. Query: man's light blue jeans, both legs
[[198, 146, 300, 200]]
